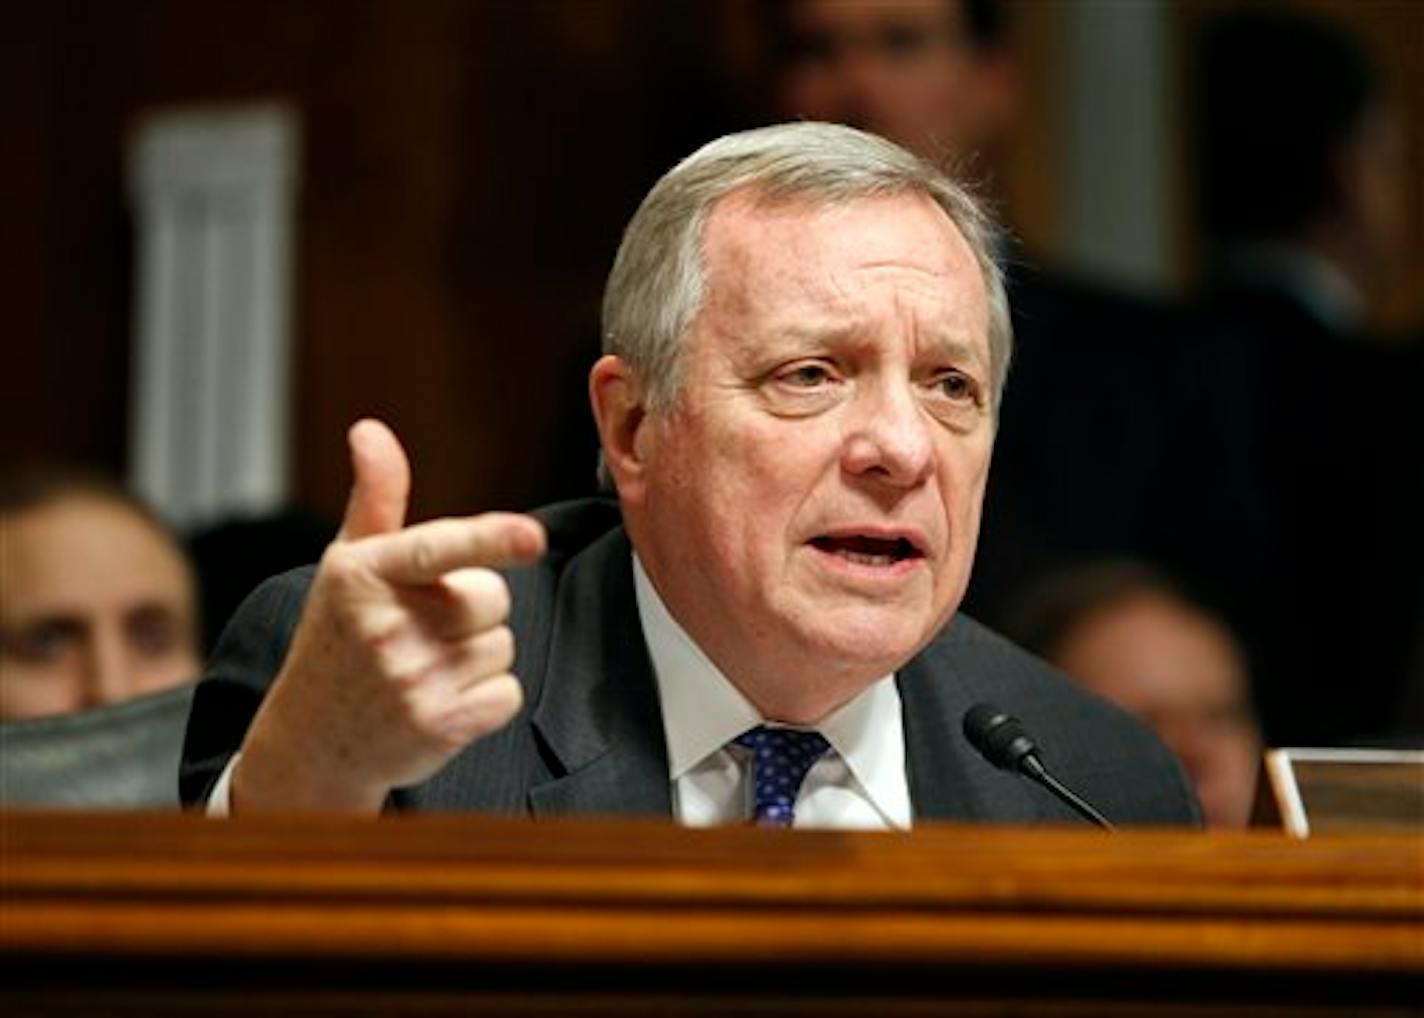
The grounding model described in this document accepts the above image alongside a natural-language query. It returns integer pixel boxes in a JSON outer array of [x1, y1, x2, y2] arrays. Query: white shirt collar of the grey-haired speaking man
[[632, 555, 911, 827]]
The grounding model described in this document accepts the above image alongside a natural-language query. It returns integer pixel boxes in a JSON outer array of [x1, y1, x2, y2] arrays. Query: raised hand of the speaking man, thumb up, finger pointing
[[232, 420, 544, 812]]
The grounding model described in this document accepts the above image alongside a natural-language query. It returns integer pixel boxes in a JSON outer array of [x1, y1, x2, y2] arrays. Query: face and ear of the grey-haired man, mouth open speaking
[[624, 192, 993, 722]]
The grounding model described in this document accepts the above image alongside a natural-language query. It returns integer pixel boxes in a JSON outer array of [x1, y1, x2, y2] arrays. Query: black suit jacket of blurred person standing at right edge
[[1200, 279, 1424, 746]]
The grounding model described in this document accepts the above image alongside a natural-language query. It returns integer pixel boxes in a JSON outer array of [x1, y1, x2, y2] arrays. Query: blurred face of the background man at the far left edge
[[0, 495, 199, 720]]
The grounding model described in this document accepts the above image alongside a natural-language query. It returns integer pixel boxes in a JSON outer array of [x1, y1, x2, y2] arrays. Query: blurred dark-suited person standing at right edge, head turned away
[[1193, 7, 1424, 745]]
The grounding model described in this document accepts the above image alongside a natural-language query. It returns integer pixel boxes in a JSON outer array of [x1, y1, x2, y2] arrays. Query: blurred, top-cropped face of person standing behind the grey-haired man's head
[[778, 0, 997, 159]]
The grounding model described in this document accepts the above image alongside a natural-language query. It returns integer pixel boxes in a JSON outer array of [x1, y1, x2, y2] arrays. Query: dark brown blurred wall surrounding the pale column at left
[[0, 0, 731, 526]]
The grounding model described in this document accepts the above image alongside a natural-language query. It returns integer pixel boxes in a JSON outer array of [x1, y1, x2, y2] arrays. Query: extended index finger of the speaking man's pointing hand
[[363, 513, 544, 584]]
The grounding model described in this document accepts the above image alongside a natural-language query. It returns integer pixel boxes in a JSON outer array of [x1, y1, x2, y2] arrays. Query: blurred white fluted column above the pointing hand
[[128, 105, 298, 527]]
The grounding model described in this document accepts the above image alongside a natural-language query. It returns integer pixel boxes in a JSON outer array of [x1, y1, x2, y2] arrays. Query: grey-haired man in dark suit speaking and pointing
[[184, 124, 1198, 827]]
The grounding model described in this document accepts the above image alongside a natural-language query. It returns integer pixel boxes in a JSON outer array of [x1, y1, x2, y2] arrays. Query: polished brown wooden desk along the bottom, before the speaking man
[[0, 813, 1424, 1017]]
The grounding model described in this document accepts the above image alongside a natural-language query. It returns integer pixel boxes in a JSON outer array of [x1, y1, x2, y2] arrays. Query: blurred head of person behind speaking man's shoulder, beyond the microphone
[[1007, 561, 1262, 829]]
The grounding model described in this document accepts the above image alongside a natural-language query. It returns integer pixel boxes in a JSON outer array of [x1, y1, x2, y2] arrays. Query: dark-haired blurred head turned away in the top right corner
[[1193, 7, 1407, 339]]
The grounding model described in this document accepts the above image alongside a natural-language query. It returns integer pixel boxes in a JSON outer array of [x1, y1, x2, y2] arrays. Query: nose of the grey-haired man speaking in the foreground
[[842, 383, 934, 488]]
